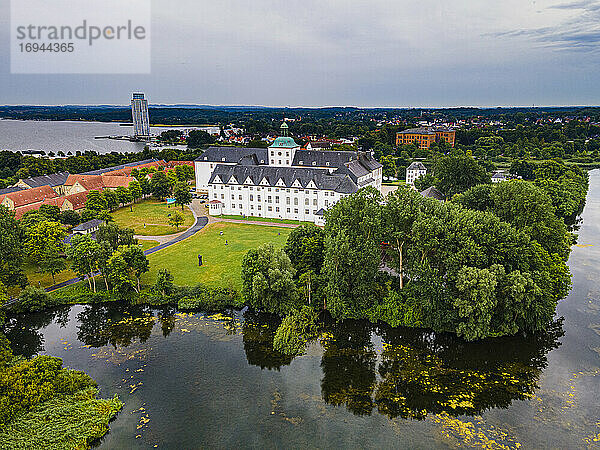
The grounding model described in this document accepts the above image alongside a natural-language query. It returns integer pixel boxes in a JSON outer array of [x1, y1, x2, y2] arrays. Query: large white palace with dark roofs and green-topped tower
[[194, 123, 382, 225]]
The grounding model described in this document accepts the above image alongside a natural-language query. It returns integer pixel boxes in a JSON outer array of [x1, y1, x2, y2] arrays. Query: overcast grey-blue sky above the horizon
[[0, 0, 600, 107]]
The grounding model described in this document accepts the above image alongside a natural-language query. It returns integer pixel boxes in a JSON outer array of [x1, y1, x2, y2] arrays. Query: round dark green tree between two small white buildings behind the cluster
[[434, 155, 491, 198]]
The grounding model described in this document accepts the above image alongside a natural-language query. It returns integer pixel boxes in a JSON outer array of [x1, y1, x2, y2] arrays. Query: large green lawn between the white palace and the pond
[[142, 222, 292, 291]]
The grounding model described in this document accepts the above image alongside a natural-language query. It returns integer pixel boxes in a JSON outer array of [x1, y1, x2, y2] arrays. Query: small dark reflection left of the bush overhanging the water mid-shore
[[242, 310, 294, 370]]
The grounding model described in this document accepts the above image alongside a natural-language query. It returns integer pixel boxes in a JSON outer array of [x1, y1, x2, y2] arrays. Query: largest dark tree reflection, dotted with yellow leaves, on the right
[[321, 322, 563, 419]]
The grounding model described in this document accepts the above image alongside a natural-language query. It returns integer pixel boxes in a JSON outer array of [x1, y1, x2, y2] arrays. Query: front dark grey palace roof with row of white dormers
[[208, 164, 358, 194]]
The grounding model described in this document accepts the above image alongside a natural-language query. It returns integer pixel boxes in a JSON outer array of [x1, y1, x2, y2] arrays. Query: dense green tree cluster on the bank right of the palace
[[242, 168, 572, 342]]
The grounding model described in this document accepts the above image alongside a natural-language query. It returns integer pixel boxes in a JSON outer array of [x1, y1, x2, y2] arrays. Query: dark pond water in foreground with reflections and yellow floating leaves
[[7, 171, 600, 449]]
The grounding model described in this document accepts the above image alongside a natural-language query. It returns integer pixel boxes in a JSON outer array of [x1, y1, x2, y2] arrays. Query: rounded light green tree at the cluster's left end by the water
[[242, 244, 301, 314]]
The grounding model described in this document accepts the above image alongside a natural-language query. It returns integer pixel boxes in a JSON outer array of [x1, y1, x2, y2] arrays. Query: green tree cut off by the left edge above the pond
[[0, 205, 27, 286]]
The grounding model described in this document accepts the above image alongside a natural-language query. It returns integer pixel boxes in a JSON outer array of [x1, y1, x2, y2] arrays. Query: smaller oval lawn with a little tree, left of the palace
[[111, 199, 194, 236]]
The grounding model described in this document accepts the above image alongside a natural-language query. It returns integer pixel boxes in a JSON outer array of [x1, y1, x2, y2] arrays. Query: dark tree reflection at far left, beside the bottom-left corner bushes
[[4, 306, 71, 358]]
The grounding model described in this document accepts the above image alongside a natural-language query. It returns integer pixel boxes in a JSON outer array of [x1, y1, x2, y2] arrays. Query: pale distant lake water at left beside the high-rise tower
[[0, 120, 185, 154]]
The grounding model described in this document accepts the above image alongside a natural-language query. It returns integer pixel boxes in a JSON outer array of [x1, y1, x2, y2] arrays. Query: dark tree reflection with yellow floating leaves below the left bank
[[77, 302, 156, 347]]
